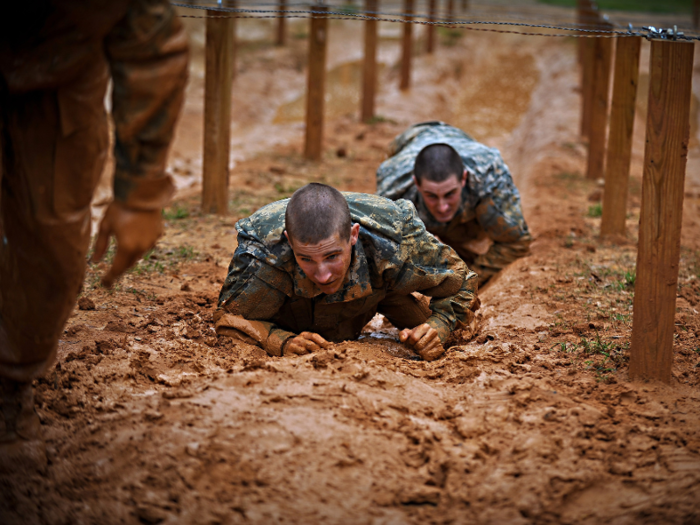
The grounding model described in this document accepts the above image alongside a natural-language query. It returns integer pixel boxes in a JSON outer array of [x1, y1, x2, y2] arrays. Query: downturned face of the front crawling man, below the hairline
[[284, 224, 360, 295]]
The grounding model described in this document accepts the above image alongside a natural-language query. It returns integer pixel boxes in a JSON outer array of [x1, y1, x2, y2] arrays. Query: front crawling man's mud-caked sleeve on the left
[[214, 237, 297, 356]]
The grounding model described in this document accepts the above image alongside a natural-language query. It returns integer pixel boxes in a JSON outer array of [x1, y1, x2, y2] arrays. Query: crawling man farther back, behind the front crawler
[[377, 122, 532, 285]]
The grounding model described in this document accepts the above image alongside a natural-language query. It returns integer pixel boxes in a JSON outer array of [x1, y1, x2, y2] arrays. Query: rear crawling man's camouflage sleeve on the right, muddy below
[[472, 176, 532, 282]]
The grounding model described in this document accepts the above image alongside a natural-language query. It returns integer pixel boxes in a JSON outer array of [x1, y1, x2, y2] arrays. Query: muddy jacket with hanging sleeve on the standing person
[[0, 0, 188, 209]]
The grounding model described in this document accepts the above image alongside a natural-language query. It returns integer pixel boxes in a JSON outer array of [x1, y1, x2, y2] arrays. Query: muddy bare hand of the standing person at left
[[91, 202, 163, 288]]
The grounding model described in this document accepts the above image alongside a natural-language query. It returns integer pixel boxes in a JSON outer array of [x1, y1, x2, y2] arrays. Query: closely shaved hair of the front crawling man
[[284, 182, 352, 244]]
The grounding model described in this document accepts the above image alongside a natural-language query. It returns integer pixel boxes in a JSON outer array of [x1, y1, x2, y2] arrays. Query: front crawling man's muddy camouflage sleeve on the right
[[392, 200, 479, 342]]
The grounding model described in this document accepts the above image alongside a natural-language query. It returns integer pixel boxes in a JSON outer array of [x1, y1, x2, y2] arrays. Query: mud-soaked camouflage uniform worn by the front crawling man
[[216, 193, 478, 355]]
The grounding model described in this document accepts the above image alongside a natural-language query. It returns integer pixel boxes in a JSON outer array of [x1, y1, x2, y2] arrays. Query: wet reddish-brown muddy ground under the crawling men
[[0, 10, 700, 525]]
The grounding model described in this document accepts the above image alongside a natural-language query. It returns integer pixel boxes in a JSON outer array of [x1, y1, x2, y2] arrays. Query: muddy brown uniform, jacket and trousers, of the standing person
[[0, 0, 188, 382]]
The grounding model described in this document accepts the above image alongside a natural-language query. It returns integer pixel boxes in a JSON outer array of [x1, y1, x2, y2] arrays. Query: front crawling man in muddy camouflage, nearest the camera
[[215, 183, 479, 360]]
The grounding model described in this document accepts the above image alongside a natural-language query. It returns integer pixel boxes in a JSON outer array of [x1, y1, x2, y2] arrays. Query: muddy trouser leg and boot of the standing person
[[0, 60, 109, 441]]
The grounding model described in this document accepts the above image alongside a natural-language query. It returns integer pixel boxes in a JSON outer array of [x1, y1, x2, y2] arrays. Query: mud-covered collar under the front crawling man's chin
[[292, 239, 372, 303]]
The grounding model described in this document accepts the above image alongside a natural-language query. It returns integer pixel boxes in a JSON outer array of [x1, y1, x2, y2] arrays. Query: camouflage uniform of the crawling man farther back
[[377, 122, 532, 283]]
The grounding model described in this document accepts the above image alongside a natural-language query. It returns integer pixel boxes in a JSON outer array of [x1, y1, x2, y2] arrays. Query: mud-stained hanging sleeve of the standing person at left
[[105, 0, 188, 210]]
